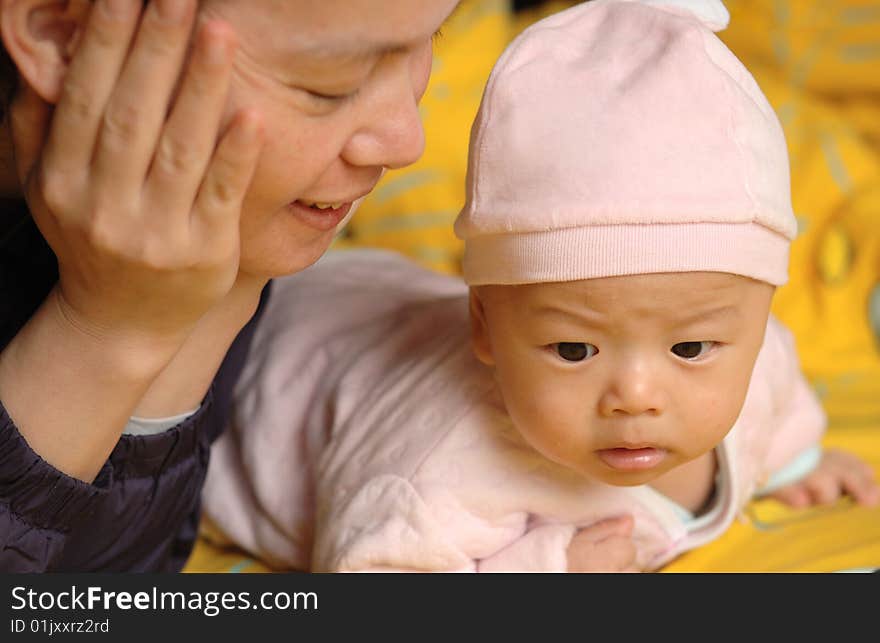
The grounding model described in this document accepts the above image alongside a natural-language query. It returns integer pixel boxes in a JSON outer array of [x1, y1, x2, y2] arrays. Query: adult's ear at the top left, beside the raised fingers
[[0, 0, 92, 104]]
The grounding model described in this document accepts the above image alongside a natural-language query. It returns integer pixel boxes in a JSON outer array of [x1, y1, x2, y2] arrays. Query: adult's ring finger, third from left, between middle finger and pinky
[[147, 23, 234, 215]]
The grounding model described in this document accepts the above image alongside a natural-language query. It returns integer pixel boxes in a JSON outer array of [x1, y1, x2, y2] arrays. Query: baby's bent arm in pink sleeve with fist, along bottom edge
[[312, 475, 636, 572]]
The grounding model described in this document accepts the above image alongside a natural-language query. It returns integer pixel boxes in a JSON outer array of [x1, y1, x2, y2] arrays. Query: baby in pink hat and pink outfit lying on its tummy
[[205, 0, 880, 571]]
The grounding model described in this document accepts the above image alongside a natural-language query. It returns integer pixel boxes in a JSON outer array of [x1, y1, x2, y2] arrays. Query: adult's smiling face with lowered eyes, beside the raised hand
[[200, 0, 458, 276]]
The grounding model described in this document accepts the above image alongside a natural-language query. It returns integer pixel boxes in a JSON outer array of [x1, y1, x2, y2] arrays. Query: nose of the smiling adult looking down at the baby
[[342, 61, 425, 169]]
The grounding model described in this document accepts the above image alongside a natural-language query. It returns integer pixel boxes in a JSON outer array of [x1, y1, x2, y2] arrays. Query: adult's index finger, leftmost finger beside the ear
[[43, 0, 142, 176]]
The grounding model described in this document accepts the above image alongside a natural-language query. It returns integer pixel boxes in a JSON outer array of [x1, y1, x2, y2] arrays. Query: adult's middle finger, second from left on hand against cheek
[[93, 0, 195, 195]]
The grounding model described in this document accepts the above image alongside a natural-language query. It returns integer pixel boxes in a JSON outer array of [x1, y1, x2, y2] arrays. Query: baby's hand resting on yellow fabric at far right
[[769, 449, 880, 508]]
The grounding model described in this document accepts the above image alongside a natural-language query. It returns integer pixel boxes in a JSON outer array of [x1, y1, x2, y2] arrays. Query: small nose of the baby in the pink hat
[[599, 361, 665, 417]]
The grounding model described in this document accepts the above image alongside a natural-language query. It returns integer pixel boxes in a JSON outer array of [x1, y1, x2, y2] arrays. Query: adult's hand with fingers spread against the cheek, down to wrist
[[12, 0, 261, 346]]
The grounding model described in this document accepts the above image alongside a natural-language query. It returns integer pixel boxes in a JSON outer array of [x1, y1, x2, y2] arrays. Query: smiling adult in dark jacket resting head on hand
[[0, 0, 457, 572]]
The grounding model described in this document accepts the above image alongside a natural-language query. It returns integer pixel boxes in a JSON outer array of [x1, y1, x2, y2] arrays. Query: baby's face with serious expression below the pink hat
[[471, 272, 774, 485]]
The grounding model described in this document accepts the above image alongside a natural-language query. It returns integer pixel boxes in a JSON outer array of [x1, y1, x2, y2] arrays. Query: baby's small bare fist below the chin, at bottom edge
[[567, 516, 640, 572]]
